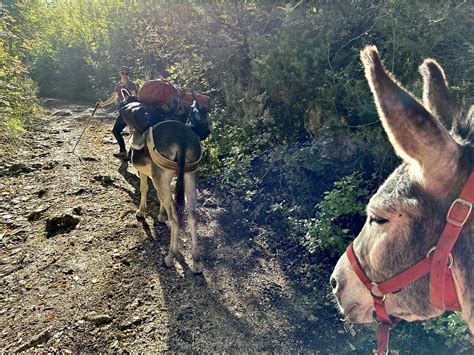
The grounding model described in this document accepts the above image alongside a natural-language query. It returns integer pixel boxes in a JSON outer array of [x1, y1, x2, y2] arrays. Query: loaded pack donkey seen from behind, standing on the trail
[[120, 93, 202, 273]]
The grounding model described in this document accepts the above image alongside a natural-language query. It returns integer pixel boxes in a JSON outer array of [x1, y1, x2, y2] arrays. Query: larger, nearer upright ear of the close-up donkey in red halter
[[361, 46, 460, 186]]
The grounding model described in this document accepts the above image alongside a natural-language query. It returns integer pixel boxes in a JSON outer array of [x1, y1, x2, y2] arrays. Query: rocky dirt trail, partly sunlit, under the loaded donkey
[[0, 105, 351, 353]]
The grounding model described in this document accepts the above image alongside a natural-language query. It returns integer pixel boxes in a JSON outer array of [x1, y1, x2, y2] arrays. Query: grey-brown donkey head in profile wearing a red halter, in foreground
[[331, 46, 474, 352]]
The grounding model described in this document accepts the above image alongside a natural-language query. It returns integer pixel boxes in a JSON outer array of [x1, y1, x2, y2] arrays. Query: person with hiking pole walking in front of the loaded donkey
[[97, 66, 138, 159]]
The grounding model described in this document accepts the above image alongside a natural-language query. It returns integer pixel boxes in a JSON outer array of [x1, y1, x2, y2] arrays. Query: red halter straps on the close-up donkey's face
[[346, 171, 474, 354]]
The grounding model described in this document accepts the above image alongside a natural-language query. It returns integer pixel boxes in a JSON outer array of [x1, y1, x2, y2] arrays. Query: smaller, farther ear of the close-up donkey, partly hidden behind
[[418, 59, 461, 130]]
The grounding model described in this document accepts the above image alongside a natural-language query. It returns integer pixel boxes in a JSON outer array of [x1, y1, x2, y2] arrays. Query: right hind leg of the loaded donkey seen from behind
[[184, 172, 202, 274]]
